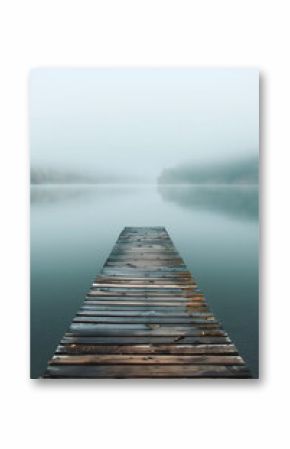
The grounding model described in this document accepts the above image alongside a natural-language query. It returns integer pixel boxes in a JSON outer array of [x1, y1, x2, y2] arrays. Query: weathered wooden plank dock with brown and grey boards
[[43, 227, 251, 378]]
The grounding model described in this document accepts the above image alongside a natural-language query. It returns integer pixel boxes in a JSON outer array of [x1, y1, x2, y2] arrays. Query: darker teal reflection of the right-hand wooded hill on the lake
[[158, 185, 259, 220]]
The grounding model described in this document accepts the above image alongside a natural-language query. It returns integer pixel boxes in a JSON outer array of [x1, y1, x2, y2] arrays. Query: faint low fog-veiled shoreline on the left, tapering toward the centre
[[30, 167, 149, 185]]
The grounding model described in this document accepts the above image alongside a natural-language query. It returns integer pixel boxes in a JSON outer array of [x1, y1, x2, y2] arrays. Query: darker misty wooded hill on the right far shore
[[158, 157, 259, 184]]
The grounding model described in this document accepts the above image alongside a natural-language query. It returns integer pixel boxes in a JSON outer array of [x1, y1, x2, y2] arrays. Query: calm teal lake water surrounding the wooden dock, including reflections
[[31, 185, 258, 378]]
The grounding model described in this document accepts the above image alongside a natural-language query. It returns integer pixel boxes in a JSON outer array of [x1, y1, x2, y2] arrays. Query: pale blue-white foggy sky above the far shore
[[29, 69, 259, 178]]
